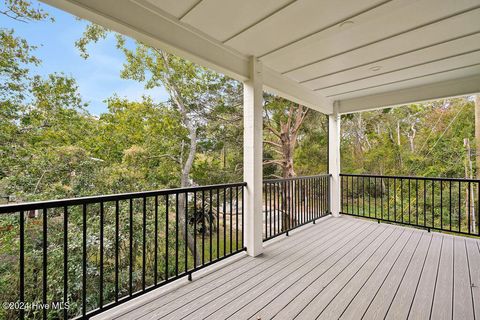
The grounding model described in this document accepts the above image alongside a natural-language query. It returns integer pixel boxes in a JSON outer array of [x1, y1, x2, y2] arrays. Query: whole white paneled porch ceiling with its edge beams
[[43, 0, 480, 114]]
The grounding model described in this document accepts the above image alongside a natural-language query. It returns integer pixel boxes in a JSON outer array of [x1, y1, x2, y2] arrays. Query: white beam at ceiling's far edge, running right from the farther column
[[338, 75, 480, 114]]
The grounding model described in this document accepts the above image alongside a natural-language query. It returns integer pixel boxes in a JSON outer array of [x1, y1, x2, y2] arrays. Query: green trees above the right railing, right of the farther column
[[341, 98, 475, 178]]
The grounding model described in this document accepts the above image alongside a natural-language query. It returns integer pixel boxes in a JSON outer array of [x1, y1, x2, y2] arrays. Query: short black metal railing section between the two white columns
[[263, 175, 330, 241]]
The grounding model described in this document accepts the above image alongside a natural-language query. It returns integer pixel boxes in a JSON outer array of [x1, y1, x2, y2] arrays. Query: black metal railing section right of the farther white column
[[340, 174, 480, 236]]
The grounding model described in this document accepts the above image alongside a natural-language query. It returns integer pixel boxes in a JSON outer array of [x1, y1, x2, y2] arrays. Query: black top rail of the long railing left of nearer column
[[0, 182, 247, 214]]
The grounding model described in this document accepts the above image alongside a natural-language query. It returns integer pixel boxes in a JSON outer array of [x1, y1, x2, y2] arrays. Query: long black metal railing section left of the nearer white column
[[0, 183, 246, 319]]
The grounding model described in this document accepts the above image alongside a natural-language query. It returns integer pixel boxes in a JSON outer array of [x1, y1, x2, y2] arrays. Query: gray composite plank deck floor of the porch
[[95, 216, 480, 320]]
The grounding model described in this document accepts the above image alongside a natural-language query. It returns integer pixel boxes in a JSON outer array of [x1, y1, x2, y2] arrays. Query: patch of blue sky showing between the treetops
[[0, 0, 168, 115]]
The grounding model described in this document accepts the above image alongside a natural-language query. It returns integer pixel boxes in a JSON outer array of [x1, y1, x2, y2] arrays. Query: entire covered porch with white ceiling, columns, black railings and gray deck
[[0, 0, 480, 319]]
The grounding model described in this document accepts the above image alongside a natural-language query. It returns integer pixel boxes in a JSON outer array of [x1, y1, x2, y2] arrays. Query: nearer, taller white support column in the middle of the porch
[[243, 57, 263, 257]]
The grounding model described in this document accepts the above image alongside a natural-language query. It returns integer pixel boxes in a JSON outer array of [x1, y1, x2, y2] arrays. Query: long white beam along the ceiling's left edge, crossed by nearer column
[[41, 0, 331, 113]]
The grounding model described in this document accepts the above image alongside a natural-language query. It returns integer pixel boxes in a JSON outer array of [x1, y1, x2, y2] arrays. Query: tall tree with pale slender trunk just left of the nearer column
[[76, 24, 246, 259]]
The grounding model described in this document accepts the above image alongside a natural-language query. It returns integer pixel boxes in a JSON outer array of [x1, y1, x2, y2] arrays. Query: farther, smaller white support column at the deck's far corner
[[328, 103, 341, 217]]
